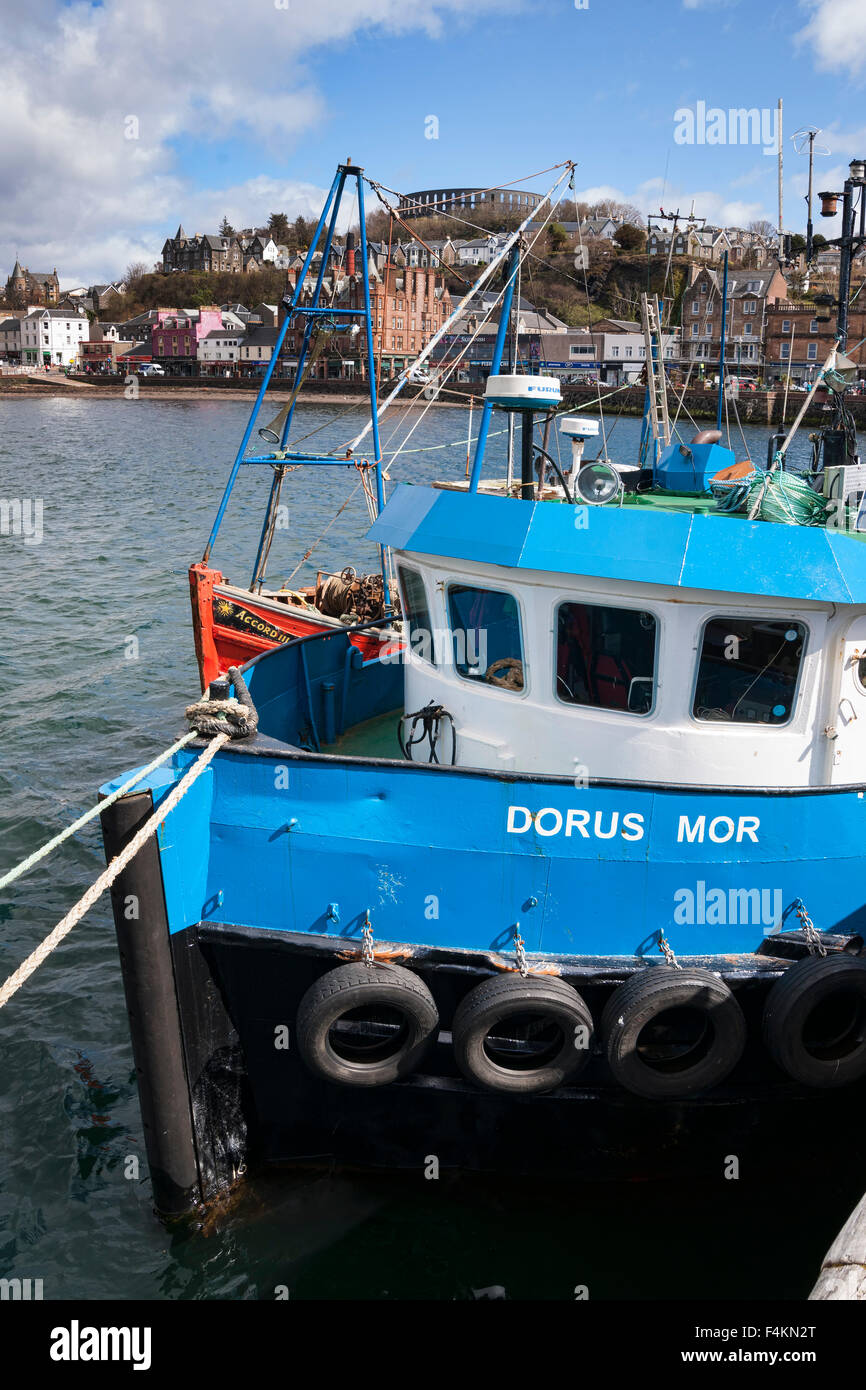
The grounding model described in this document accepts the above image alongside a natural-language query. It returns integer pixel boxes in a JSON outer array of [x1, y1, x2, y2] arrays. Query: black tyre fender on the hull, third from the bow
[[602, 965, 746, 1099]]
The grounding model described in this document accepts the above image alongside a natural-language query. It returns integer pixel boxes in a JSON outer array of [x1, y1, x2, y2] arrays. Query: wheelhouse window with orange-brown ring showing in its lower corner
[[448, 584, 525, 691]]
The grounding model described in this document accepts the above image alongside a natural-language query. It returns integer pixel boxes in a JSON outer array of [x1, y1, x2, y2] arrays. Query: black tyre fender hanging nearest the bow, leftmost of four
[[295, 962, 439, 1086]]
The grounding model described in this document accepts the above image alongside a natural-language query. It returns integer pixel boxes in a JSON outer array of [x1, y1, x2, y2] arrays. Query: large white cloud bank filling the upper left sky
[[0, 0, 520, 285]]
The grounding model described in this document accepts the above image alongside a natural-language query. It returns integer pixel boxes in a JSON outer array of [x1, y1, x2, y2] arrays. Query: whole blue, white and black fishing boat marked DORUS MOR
[[101, 157, 866, 1215]]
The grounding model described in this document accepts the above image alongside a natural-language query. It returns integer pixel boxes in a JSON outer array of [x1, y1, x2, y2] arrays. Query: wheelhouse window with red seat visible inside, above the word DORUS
[[556, 603, 657, 714]]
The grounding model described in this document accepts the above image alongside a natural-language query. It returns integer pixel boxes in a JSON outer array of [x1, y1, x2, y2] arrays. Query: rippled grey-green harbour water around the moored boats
[[0, 398, 862, 1300]]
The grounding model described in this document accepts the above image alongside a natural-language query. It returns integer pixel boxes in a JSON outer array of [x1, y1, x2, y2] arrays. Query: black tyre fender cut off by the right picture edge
[[763, 952, 866, 1087]]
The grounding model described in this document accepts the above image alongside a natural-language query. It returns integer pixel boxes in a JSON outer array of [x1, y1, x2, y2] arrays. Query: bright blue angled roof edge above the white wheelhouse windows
[[367, 484, 866, 603]]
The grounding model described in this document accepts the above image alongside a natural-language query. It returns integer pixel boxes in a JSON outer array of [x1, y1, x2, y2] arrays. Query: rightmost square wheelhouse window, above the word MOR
[[692, 617, 806, 724]]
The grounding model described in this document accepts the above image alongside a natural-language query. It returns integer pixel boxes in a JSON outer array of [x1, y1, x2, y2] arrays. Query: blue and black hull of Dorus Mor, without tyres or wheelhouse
[[97, 634, 866, 1212]]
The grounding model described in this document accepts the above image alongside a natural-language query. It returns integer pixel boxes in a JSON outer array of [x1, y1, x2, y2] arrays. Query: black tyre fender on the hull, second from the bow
[[452, 974, 594, 1095]]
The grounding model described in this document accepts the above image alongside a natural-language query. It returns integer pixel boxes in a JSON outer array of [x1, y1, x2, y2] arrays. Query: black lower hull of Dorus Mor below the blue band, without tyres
[[104, 778, 866, 1215]]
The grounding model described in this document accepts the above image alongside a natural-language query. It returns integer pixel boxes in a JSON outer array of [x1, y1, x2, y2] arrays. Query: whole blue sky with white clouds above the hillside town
[[0, 0, 866, 284]]
